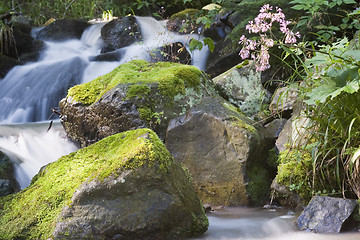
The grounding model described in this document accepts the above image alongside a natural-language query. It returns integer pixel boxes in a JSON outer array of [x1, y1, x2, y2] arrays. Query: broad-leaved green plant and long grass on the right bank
[[303, 36, 360, 197]]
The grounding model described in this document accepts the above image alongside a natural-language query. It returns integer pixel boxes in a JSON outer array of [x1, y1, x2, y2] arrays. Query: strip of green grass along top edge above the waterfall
[[0, 0, 211, 25]]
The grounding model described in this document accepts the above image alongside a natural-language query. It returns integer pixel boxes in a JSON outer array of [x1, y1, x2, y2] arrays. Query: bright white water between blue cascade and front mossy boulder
[[0, 122, 77, 189]]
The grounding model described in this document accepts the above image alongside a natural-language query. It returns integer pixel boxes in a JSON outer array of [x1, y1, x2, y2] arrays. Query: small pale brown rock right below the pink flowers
[[269, 87, 299, 116]]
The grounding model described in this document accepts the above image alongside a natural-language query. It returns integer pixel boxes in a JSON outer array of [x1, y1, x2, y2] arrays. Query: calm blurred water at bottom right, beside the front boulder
[[193, 208, 360, 240]]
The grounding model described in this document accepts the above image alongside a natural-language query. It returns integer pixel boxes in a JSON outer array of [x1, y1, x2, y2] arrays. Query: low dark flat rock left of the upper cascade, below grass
[[37, 19, 90, 41]]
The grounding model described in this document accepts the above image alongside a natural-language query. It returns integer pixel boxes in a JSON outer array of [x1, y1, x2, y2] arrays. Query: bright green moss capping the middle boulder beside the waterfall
[[68, 60, 201, 105]]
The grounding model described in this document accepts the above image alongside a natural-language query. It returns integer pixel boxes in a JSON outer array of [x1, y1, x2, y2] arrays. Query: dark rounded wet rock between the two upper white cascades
[[101, 16, 142, 53]]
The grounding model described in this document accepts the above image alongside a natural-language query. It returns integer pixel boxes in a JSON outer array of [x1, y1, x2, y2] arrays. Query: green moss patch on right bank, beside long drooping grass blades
[[276, 149, 312, 202]]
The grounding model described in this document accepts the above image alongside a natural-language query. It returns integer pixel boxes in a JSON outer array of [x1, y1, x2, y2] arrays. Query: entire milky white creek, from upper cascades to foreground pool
[[0, 17, 360, 240]]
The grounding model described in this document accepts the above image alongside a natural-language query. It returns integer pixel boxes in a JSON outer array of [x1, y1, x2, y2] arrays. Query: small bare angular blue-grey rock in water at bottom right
[[296, 196, 357, 234]]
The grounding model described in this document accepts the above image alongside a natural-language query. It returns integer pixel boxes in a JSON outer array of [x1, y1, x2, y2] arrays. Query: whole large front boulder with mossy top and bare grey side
[[0, 129, 208, 239]]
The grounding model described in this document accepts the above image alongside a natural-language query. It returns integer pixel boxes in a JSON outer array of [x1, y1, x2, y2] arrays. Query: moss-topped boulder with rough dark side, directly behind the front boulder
[[60, 60, 214, 146]]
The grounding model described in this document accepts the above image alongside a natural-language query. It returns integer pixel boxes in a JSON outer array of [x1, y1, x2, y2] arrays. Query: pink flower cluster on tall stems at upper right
[[239, 4, 300, 71]]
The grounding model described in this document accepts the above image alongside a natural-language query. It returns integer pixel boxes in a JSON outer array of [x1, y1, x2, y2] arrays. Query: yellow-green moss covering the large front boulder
[[0, 129, 172, 239]]
